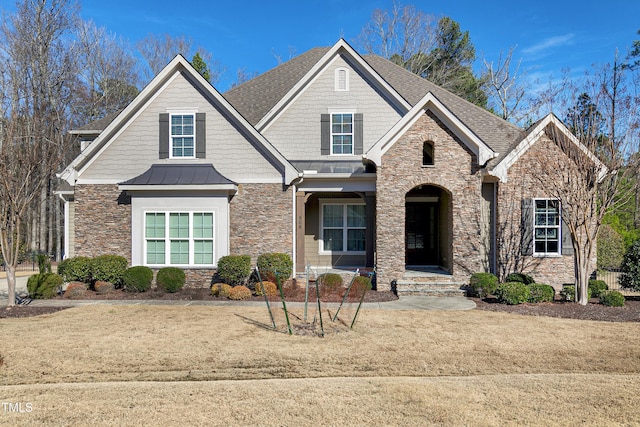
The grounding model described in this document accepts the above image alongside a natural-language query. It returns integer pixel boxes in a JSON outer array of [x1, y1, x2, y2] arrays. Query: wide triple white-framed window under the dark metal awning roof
[[144, 212, 215, 266]]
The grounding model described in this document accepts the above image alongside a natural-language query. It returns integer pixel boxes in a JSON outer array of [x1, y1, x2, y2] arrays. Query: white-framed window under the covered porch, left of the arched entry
[[320, 202, 366, 253]]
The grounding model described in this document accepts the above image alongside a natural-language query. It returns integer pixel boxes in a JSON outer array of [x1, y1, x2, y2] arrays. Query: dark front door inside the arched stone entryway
[[405, 202, 439, 265]]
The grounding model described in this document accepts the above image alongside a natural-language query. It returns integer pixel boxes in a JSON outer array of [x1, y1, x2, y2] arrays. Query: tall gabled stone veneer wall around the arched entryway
[[376, 113, 484, 290]]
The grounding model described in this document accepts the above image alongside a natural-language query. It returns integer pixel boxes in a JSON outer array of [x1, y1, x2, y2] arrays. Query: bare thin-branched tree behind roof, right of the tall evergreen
[[482, 47, 526, 122]]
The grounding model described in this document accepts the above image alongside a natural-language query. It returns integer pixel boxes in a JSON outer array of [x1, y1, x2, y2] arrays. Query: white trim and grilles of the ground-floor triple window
[[142, 209, 216, 268]]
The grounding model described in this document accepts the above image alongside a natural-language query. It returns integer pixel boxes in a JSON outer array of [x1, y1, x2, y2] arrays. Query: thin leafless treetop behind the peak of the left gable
[[136, 33, 224, 85]]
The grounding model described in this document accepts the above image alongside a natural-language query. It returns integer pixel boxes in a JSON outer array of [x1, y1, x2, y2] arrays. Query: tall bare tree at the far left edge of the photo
[[0, 0, 78, 306]]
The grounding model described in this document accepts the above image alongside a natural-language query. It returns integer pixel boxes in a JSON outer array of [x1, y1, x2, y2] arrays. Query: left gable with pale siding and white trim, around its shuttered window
[[60, 56, 298, 184]]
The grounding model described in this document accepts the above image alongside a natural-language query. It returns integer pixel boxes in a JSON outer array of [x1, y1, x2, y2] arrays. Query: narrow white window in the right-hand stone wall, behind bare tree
[[533, 199, 562, 255]]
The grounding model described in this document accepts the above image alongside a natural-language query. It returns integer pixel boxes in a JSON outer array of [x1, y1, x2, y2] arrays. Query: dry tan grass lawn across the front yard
[[0, 305, 640, 426]]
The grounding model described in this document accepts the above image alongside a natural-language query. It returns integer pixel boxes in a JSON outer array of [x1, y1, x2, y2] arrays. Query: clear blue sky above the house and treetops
[[0, 0, 640, 91]]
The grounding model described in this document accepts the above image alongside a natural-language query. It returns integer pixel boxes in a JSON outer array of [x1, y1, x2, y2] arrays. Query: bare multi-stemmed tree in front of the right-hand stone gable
[[537, 57, 640, 305]]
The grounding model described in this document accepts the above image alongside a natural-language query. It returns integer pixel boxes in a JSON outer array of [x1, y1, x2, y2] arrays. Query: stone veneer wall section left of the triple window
[[74, 184, 131, 263]]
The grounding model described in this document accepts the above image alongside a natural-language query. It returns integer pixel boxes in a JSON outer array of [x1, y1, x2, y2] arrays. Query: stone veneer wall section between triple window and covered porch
[[229, 184, 293, 264]]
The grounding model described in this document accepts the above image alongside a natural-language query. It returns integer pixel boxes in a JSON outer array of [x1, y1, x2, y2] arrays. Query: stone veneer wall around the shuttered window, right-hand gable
[[497, 132, 596, 290]]
